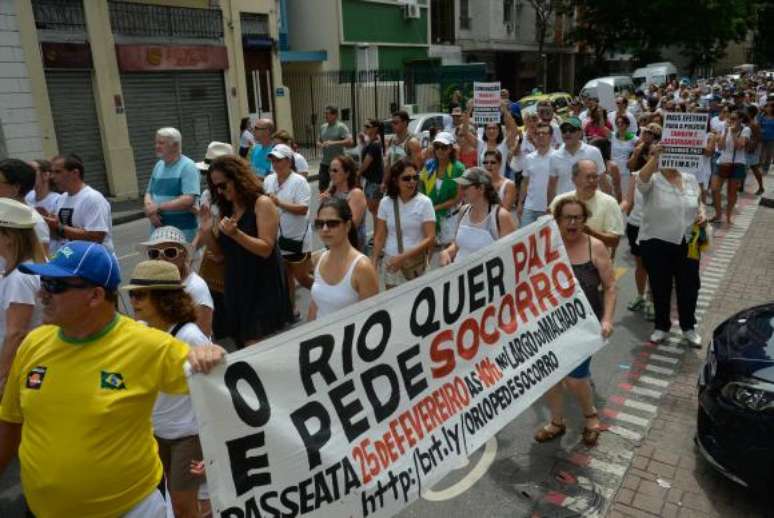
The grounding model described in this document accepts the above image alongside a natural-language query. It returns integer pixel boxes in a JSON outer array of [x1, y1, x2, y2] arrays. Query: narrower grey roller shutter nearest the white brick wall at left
[[46, 70, 110, 196]]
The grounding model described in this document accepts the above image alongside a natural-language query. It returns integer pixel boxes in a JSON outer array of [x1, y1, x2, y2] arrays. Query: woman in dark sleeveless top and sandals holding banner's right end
[[535, 196, 616, 446]]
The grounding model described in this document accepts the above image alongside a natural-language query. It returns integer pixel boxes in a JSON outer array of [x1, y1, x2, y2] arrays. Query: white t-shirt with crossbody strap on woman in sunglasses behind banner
[[376, 192, 435, 257]]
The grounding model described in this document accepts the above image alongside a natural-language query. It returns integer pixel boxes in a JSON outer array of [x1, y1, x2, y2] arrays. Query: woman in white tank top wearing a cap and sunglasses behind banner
[[440, 167, 516, 266]]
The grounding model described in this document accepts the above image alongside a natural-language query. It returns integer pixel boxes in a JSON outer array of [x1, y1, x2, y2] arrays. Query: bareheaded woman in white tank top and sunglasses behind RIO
[[308, 198, 379, 321]]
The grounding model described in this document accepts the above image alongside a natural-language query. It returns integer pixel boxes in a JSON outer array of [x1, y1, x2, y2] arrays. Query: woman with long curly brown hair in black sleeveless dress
[[200, 156, 292, 349]]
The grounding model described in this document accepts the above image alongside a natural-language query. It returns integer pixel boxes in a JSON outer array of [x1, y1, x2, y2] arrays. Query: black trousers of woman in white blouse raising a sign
[[640, 239, 701, 332]]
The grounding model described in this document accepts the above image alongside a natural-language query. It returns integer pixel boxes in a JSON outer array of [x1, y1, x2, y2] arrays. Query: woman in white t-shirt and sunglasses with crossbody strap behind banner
[[371, 159, 440, 289]]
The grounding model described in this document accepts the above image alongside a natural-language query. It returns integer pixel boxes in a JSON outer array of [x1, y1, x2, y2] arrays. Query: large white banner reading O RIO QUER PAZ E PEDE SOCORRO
[[189, 218, 603, 518]]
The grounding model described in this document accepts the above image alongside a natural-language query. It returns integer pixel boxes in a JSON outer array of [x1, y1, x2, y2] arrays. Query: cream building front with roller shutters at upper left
[[0, 0, 291, 198]]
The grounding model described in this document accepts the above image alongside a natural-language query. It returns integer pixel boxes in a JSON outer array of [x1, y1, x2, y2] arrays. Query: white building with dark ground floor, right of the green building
[[430, 0, 577, 97]]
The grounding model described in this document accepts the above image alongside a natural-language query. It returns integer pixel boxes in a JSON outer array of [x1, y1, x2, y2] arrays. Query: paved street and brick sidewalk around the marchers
[[0, 177, 774, 518]]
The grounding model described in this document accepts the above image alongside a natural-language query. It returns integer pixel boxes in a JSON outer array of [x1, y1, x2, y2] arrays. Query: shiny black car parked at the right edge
[[696, 303, 774, 491]]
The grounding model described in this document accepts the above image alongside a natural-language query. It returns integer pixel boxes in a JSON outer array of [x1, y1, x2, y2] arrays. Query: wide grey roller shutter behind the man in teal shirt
[[121, 72, 230, 193]]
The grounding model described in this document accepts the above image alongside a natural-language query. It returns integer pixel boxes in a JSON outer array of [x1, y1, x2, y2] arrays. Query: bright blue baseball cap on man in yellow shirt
[[19, 241, 121, 291]]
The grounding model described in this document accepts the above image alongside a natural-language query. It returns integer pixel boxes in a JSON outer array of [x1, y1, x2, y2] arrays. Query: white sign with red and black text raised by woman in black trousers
[[658, 112, 709, 173]]
